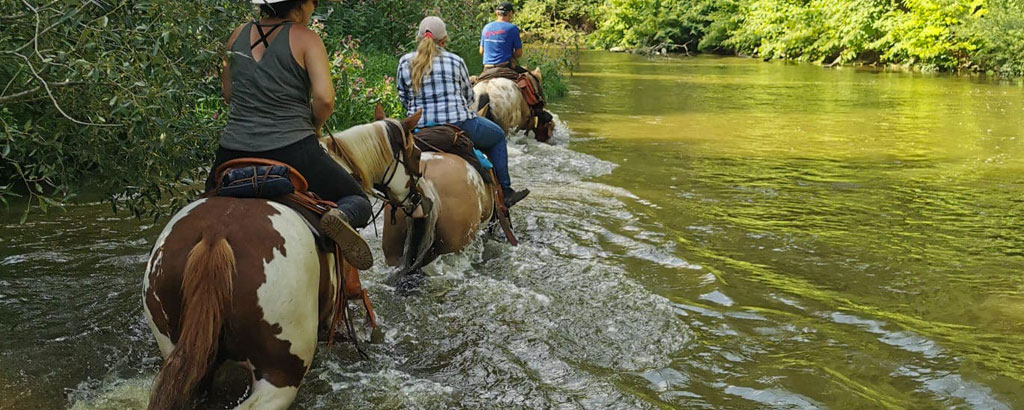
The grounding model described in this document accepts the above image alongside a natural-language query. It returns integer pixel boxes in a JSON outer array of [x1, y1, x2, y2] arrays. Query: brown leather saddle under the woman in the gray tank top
[[203, 158, 377, 353]]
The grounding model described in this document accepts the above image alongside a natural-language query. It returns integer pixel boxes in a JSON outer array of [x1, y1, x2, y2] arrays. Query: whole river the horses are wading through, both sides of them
[[0, 52, 1024, 409]]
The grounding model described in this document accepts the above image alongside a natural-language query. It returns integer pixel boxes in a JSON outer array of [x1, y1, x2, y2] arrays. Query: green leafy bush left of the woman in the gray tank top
[[0, 0, 245, 221]]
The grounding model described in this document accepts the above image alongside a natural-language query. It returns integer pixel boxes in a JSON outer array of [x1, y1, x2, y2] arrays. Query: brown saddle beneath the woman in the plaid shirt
[[413, 124, 519, 246]]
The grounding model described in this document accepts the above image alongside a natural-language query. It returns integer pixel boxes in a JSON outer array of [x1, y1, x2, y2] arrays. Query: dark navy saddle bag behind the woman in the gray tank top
[[217, 165, 295, 198]]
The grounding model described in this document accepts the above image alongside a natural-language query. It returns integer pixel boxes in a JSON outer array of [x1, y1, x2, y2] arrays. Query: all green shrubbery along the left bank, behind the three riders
[[0, 0, 568, 216]]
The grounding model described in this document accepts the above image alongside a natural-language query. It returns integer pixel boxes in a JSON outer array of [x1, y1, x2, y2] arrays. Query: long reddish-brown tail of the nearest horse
[[150, 236, 236, 410]]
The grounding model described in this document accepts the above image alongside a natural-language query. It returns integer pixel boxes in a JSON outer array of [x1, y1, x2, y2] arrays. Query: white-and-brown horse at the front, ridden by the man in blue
[[473, 69, 555, 142]]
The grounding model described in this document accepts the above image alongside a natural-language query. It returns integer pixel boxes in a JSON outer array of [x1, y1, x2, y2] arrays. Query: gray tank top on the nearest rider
[[220, 23, 313, 152]]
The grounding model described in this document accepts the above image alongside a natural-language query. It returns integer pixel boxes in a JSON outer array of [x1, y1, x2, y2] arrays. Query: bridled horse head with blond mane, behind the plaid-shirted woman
[[321, 104, 423, 214]]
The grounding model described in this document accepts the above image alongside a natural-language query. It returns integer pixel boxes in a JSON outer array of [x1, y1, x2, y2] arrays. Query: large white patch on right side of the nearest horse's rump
[[256, 202, 319, 368]]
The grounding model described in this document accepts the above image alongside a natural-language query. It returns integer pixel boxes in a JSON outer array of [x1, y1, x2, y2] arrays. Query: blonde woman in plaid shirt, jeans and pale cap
[[395, 16, 529, 206]]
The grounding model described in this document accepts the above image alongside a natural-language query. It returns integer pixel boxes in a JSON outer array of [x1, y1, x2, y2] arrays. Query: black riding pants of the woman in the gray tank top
[[206, 135, 373, 228]]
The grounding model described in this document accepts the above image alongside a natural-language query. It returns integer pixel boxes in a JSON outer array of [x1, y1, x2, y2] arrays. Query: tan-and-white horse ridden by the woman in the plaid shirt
[[382, 108, 517, 284]]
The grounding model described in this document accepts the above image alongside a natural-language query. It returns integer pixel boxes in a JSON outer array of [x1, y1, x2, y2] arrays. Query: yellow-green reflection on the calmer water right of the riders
[[555, 54, 1024, 408]]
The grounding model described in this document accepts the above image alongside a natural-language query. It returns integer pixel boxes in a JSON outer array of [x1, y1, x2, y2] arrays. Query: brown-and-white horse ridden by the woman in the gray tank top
[[143, 109, 420, 409]]
